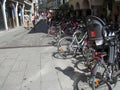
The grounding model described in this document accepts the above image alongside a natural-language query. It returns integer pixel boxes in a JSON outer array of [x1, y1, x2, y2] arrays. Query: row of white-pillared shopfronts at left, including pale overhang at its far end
[[0, 0, 34, 30]]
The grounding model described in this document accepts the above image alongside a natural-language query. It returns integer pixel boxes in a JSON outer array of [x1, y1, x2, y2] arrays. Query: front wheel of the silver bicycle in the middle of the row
[[57, 37, 77, 59]]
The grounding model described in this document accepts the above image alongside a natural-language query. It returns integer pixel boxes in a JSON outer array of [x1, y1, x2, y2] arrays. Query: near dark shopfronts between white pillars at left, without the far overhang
[[0, 0, 24, 30]]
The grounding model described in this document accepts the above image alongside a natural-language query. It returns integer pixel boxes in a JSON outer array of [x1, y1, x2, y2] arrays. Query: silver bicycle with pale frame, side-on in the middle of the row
[[57, 27, 87, 59]]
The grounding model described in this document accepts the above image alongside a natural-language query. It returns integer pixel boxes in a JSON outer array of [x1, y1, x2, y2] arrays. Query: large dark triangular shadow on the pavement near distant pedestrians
[[29, 20, 47, 34]]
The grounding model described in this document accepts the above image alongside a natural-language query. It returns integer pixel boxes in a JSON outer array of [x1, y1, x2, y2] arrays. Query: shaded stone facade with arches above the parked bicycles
[[69, 0, 120, 21]]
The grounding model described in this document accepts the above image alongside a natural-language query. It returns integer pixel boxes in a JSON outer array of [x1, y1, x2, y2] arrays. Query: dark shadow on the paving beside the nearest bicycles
[[55, 67, 88, 90]]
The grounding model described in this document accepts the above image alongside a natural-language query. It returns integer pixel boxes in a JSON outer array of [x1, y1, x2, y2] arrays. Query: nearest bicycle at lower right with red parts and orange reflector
[[90, 24, 120, 90]]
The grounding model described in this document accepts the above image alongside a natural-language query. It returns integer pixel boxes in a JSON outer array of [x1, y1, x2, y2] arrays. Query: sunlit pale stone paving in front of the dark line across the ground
[[0, 47, 73, 90]]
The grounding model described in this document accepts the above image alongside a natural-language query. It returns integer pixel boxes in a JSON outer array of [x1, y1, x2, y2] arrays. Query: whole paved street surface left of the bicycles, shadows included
[[0, 20, 120, 90]]
